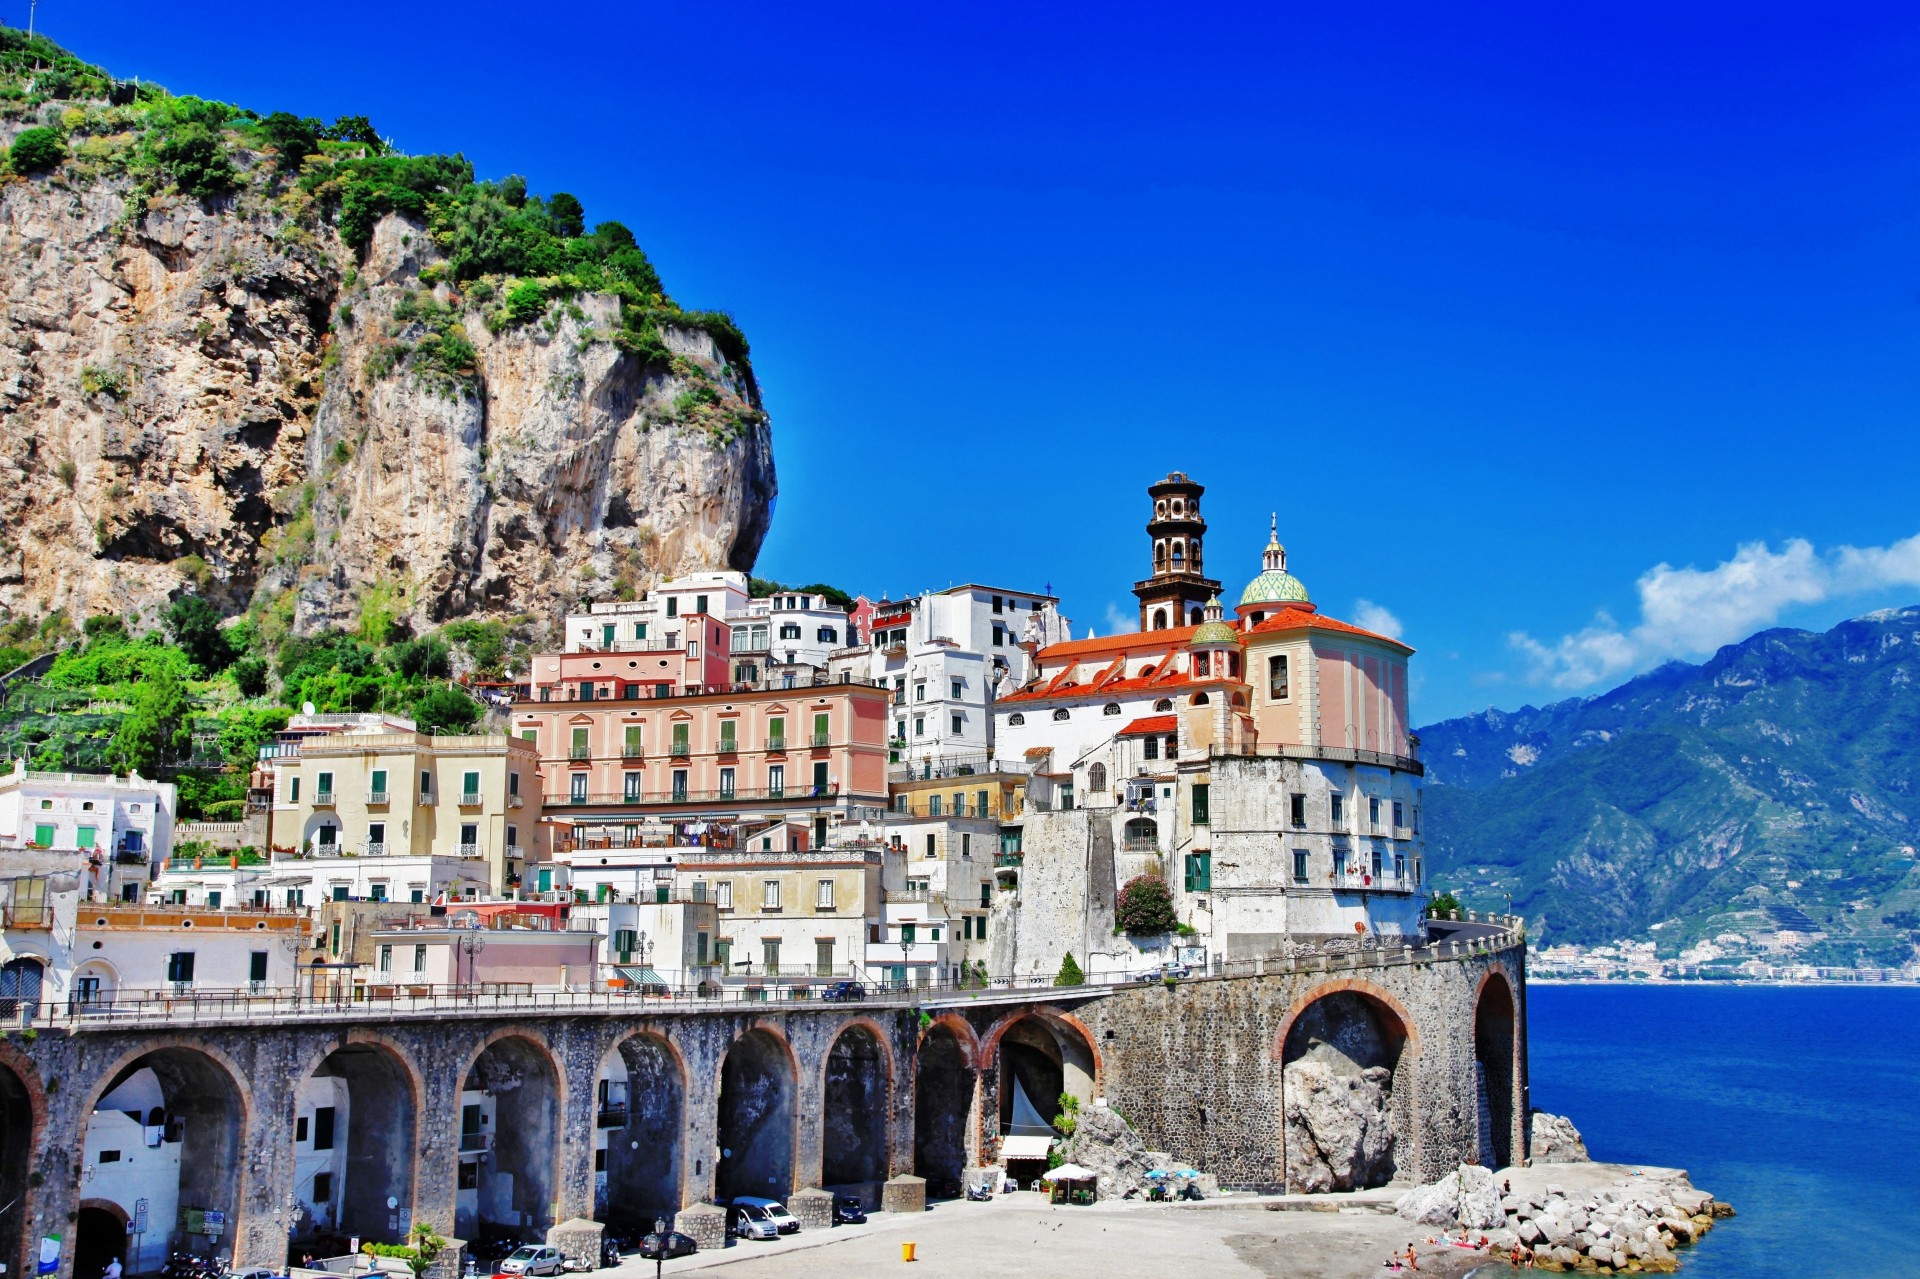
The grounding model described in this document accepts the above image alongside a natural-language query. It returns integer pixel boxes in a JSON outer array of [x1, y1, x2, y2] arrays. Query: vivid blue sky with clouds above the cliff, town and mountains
[[30, 0, 1920, 722]]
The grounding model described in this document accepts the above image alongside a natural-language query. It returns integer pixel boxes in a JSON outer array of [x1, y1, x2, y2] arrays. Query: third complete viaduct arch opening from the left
[[453, 1037, 559, 1243]]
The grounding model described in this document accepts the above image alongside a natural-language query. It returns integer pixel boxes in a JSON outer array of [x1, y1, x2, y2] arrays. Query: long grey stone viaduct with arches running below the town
[[0, 928, 1526, 1279]]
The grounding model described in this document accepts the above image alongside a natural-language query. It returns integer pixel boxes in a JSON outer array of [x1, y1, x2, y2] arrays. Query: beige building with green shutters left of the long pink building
[[267, 732, 540, 891]]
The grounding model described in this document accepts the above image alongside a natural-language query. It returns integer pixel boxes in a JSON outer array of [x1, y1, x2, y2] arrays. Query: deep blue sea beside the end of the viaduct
[[1526, 985, 1920, 1279]]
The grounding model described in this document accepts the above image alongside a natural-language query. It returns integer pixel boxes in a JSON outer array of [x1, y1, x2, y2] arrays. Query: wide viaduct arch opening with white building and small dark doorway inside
[[73, 1049, 246, 1275]]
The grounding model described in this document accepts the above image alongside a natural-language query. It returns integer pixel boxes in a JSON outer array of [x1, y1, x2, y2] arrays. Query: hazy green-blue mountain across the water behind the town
[[1419, 607, 1920, 962]]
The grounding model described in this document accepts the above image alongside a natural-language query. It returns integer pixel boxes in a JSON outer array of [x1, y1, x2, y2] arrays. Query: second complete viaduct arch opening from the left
[[288, 1043, 419, 1258]]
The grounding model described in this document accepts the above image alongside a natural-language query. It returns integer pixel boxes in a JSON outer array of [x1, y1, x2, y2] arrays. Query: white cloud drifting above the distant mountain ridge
[[1507, 534, 1920, 689]]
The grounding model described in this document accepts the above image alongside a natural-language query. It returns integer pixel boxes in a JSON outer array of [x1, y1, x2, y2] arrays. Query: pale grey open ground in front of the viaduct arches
[[616, 1195, 1484, 1279]]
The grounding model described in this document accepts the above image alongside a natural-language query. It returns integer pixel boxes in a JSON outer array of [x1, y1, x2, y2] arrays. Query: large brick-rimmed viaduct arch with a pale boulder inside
[[1275, 979, 1421, 1193]]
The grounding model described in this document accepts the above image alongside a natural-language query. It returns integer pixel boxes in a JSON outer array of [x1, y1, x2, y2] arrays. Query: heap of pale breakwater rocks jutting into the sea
[[1394, 1164, 1734, 1275]]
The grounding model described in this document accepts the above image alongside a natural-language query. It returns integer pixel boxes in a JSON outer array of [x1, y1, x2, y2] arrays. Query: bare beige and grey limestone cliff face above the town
[[0, 179, 776, 630]]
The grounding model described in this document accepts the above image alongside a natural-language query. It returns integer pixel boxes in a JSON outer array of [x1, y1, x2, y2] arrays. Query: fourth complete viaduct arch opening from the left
[[593, 1035, 685, 1235]]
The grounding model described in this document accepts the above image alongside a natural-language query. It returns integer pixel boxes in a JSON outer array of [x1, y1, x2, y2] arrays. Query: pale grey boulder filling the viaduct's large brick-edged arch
[[1283, 1056, 1394, 1193]]
